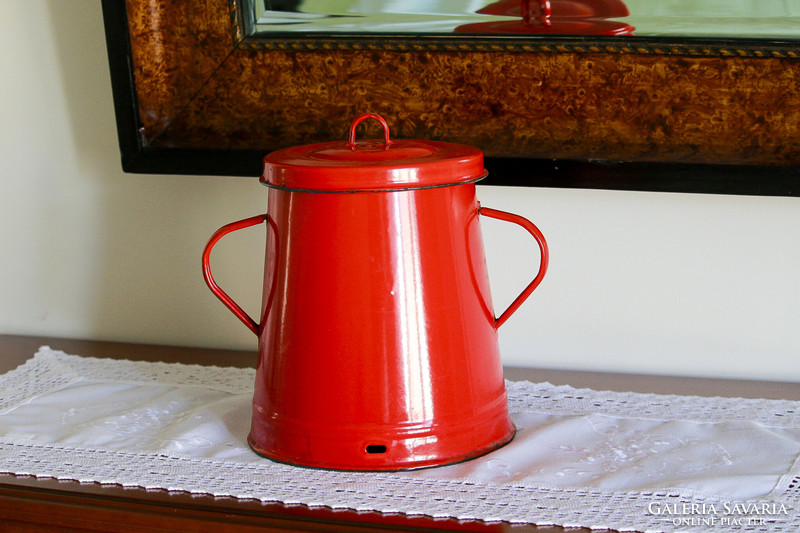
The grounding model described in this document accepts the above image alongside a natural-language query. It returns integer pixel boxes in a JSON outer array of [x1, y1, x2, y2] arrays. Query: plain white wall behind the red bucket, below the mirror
[[0, 0, 800, 380]]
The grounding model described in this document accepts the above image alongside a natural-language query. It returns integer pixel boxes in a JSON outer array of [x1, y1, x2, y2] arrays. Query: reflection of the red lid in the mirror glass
[[455, 0, 634, 35]]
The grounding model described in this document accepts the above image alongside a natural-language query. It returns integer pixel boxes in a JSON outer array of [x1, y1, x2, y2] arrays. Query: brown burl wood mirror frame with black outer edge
[[102, 0, 800, 195]]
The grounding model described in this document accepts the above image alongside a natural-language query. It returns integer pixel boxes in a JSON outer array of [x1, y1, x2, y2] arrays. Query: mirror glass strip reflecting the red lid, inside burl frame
[[253, 0, 800, 40]]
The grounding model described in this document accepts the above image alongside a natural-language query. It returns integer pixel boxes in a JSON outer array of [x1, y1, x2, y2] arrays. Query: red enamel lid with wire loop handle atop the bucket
[[261, 113, 486, 192]]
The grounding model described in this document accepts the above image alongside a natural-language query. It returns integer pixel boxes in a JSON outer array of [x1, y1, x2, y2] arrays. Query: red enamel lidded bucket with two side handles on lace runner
[[203, 115, 548, 470]]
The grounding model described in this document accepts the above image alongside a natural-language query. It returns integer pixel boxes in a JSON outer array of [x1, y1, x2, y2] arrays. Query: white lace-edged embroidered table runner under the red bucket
[[0, 347, 800, 533]]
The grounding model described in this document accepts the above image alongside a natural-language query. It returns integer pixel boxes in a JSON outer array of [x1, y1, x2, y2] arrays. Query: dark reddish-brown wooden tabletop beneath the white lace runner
[[0, 335, 800, 533]]
